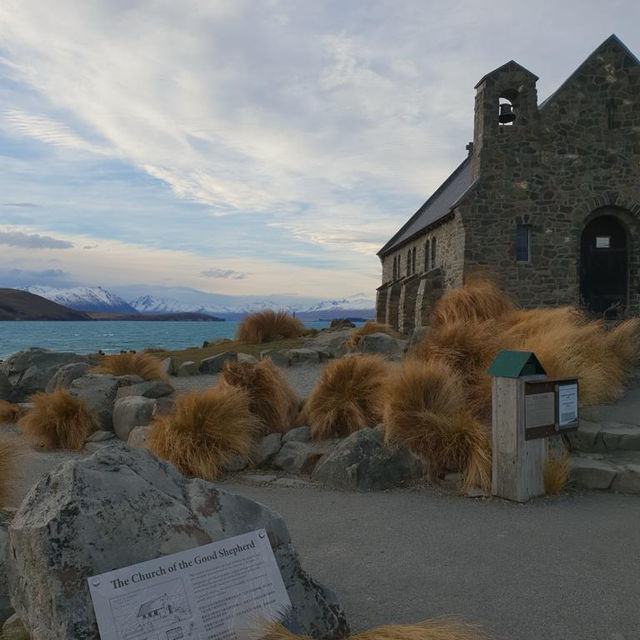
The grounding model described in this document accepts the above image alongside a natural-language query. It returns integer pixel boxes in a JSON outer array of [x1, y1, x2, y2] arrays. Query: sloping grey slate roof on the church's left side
[[378, 157, 473, 256]]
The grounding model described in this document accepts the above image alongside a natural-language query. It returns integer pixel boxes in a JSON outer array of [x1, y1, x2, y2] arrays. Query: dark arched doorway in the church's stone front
[[580, 215, 628, 314]]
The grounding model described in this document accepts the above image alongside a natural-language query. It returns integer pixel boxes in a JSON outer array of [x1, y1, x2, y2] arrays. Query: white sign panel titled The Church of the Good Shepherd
[[88, 529, 291, 640]]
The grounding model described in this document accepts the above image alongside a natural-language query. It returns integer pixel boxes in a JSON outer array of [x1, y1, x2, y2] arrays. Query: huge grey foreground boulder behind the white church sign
[[9, 446, 348, 640]]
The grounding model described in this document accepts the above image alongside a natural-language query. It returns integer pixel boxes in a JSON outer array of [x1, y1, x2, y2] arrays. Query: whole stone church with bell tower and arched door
[[376, 35, 640, 332]]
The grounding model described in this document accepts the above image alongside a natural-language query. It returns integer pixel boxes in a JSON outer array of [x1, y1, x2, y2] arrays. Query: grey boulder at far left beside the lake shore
[[3, 349, 88, 402]]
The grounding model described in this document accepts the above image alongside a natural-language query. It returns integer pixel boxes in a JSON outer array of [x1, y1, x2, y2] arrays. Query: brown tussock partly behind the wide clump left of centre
[[222, 358, 300, 434]]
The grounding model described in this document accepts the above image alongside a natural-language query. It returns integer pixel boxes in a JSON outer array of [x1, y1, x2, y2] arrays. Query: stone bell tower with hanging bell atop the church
[[472, 60, 538, 179]]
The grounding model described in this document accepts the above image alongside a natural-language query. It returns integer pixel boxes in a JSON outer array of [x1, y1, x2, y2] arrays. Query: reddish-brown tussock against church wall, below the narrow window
[[429, 276, 514, 329]]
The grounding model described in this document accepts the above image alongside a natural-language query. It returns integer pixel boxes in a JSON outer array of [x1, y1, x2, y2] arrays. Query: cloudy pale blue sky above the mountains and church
[[0, 0, 640, 297]]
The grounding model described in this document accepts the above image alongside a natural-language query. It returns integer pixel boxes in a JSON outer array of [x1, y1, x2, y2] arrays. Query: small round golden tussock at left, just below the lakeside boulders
[[18, 389, 96, 451]]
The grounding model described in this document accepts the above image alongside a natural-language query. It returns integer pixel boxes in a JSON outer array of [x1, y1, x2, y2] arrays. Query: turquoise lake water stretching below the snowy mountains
[[0, 320, 348, 359]]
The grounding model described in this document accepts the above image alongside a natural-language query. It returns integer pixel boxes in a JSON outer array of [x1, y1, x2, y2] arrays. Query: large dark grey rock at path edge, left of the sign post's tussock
[[313, 427, 425, 491]]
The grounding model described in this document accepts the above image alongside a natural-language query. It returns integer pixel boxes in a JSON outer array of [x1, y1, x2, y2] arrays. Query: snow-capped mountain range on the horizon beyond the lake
[[25, 285, 375, 320]]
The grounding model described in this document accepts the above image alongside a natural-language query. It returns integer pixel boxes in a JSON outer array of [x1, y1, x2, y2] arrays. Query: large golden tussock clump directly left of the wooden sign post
[[384, 359, 491, 490]]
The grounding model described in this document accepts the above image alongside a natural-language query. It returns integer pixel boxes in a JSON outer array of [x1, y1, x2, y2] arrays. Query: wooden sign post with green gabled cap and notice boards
[[488, 351, 578, 502]]
